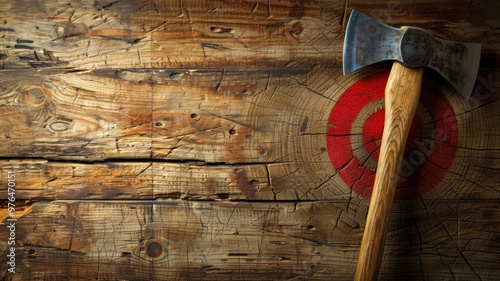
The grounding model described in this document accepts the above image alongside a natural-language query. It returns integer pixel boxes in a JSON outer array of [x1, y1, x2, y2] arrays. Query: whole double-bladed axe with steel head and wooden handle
[[343, 10, 481, 280]]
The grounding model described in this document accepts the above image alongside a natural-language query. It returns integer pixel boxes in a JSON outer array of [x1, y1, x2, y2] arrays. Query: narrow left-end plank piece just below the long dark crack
[[1, 160, 153, 202]]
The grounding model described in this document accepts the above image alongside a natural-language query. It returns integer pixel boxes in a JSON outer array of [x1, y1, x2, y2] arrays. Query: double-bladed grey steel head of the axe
[[344, 10, 481, 99]]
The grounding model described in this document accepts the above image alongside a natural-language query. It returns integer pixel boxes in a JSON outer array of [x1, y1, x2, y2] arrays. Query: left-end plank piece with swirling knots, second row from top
[[0, 68, 152, 161]]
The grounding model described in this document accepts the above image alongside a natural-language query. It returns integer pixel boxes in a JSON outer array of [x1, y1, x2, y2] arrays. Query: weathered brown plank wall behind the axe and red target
[[0, 0, 500, 280]]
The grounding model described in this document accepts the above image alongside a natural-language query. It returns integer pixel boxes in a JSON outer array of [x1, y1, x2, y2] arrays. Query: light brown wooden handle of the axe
[[354, 62, 423, 281]]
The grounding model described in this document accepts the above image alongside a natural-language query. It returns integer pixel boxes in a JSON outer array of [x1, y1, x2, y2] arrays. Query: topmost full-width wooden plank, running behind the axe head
[[0, 0, 500, 69]]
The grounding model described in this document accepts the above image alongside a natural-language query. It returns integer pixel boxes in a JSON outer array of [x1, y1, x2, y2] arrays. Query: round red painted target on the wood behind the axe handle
[[326, 71, 458, 199]]
